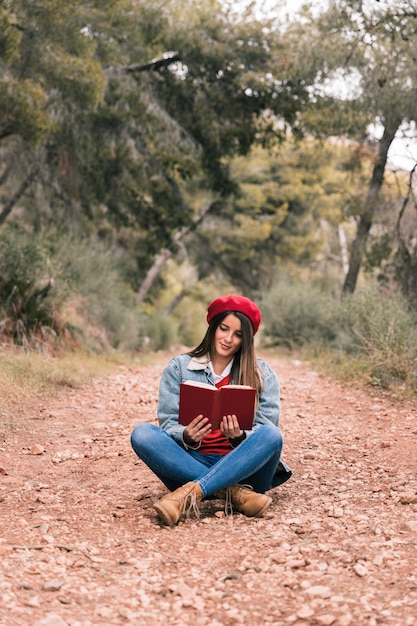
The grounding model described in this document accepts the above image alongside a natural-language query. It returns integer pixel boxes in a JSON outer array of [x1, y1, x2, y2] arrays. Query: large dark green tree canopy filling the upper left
[[0, 0, 307, 288]]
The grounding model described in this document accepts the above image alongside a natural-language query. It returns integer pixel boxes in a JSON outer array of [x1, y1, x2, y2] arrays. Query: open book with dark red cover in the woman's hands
[[178, 380, 256, 430]]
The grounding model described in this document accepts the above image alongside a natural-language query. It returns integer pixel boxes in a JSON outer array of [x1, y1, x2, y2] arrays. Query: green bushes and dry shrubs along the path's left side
[[0, 229, 140, 350]]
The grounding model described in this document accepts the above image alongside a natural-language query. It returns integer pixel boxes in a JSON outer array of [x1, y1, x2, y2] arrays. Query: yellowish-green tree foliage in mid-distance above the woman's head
[[195, 139, 364, 293]]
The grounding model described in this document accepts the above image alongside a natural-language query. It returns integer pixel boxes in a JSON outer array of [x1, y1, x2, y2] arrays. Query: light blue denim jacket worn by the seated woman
[[158, 354, 280, 446]]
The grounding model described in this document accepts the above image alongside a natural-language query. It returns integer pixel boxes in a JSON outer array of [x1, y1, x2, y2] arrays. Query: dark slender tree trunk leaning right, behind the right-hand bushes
[[343, 125, 401, 293]]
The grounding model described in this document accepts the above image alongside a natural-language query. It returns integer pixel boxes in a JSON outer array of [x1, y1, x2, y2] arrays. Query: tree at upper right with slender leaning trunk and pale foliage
[[290, 0, 417, 297]]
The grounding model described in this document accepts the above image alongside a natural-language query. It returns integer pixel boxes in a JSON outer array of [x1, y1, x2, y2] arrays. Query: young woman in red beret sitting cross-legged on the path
[[131, 294, 291, 526]]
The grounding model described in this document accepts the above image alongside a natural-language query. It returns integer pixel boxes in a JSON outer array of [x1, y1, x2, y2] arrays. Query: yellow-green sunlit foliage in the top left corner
[[0, 0, 106, 146]]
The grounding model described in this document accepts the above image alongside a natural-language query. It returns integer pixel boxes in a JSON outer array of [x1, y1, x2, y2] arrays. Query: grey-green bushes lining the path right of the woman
[[261, 281, 417, 393]]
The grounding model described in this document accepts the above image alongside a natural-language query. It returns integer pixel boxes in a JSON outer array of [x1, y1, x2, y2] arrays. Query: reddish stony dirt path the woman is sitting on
[[0, 358, 417, 626]]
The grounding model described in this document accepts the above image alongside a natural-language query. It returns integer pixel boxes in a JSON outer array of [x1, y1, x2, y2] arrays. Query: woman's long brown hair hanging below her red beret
[[188, 311, 262, 393]]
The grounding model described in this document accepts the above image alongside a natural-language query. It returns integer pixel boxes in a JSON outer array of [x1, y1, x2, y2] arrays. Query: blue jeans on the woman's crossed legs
[[131, 423, 282, 498]]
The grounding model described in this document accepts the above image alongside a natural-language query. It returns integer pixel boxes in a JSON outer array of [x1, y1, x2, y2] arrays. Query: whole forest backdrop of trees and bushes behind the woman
[[0, 0, 417, 394]]
